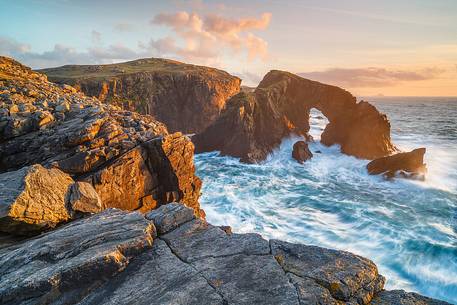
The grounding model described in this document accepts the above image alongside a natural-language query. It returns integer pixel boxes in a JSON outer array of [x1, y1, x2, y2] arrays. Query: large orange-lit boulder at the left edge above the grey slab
[[0, 164, 73, 234]]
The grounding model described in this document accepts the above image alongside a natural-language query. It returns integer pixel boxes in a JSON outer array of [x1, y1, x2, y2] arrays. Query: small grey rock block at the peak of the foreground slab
[[145, 202, 195, 234]]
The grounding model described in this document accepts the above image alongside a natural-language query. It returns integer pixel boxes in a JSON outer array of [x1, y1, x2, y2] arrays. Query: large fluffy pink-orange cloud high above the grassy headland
[[149, 11, 272, 61]]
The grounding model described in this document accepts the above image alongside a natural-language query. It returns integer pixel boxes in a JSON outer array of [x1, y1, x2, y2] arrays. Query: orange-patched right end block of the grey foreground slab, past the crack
[[270, 240, 385, 304]]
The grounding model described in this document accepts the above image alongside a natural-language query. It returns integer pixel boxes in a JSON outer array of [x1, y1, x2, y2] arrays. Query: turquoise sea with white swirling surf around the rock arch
[[196, 98, 457, 304]]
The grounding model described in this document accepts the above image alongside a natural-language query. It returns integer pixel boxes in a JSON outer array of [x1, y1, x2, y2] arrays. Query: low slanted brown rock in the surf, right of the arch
[[367, 148, 427, 179]]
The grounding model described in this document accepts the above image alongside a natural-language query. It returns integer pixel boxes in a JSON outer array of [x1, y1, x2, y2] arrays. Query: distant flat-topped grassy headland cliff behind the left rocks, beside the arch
[[41, 58, 241, 133]]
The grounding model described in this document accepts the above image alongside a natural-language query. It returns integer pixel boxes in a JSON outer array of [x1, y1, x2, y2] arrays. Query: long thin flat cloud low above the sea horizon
[[298, 67, 445, 88]]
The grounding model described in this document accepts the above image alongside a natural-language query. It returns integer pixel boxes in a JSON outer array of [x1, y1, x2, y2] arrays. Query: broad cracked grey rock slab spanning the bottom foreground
[[0, 203, 446, 305]]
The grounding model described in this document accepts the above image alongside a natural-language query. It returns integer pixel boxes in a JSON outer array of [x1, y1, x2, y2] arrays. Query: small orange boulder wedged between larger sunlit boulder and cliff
[[70, 181, 103, 213]]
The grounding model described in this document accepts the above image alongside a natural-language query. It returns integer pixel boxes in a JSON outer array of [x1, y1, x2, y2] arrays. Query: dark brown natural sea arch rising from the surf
[[192, 71, 395, 162]]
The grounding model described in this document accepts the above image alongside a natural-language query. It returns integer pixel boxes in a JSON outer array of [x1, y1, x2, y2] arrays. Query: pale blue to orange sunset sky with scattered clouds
[[0, 0, 457, 96]]
